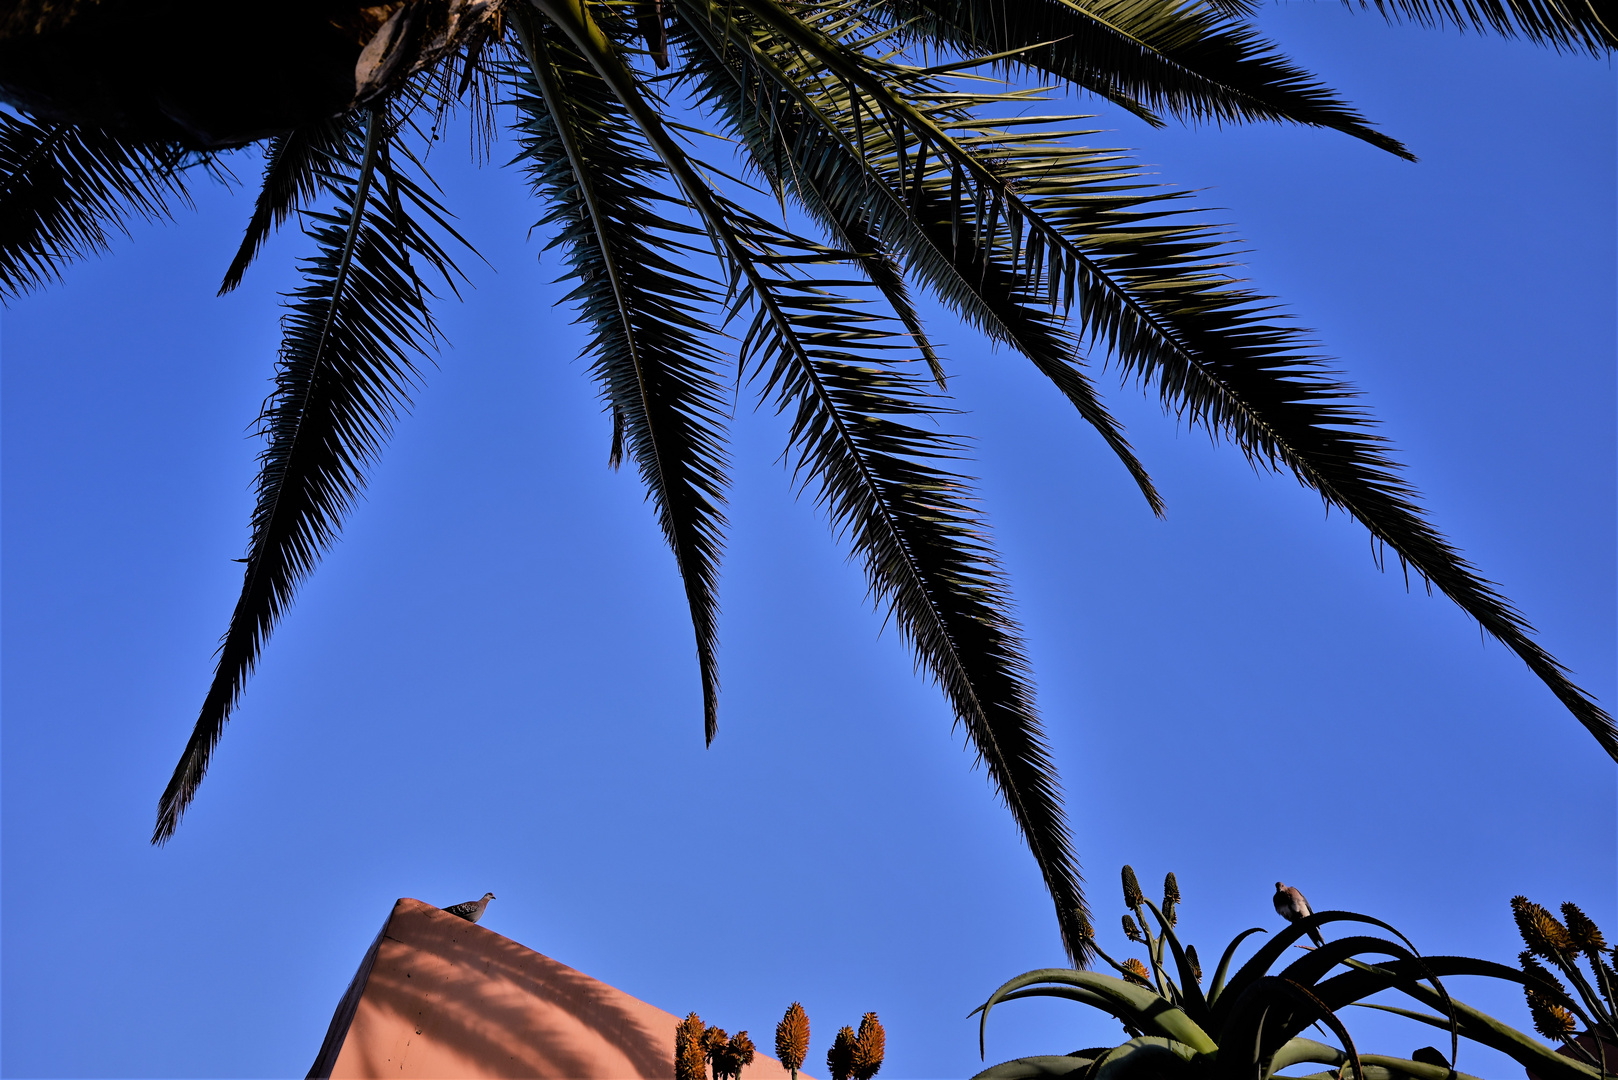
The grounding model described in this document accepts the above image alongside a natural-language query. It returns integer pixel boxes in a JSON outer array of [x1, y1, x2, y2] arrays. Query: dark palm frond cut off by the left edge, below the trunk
[[0, 112, 191, 300]]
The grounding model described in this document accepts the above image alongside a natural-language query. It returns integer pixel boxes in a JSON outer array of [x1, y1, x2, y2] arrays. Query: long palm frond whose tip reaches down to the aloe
[[536, 0, 1089, 962]]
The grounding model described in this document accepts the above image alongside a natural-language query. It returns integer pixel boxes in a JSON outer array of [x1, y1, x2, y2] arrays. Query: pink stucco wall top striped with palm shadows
[[309, 899, 804, 1080]]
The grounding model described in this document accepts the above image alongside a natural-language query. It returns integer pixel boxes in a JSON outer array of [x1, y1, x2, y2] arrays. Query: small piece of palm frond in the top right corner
[[1343, 0, 1618, 57]]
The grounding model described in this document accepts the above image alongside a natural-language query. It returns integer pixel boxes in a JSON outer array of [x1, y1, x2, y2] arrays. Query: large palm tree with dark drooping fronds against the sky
[[0, 0, 1618, 963]]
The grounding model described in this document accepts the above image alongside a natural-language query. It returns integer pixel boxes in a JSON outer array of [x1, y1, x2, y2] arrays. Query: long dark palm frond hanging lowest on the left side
[[152, 105, 455, 844]]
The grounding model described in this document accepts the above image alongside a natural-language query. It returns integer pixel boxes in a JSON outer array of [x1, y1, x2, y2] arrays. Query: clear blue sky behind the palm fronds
[[0, 3, 1618, 1077]]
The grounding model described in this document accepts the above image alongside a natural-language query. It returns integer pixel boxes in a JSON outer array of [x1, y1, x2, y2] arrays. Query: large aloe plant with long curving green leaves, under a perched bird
[[974, 873, 1613, 1080]]
